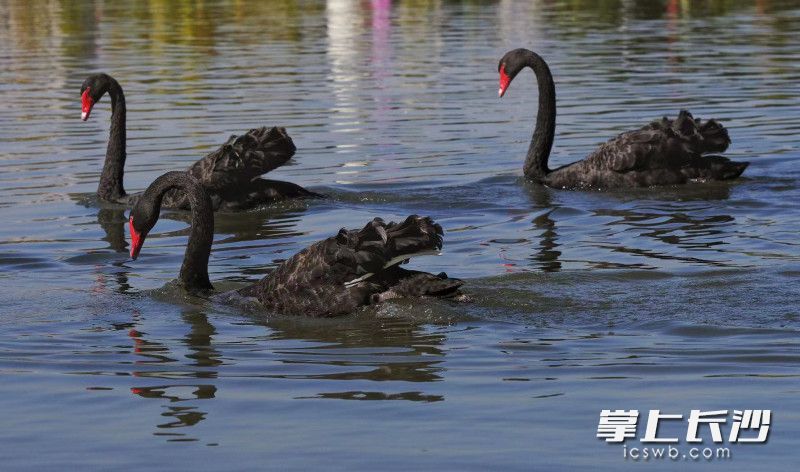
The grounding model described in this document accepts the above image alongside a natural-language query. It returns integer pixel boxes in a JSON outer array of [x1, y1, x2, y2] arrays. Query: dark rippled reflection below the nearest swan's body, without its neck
[[264, 317, 446, 396]]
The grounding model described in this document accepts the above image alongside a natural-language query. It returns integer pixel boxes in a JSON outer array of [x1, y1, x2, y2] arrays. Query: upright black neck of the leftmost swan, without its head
[[97, 77, 126, 201]]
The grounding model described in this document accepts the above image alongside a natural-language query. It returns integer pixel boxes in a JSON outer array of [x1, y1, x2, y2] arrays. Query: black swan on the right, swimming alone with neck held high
[[497, 49, 749, 189]]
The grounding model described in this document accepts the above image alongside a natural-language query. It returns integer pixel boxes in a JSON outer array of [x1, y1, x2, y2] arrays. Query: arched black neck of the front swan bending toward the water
[[142, 172, 214, 290]]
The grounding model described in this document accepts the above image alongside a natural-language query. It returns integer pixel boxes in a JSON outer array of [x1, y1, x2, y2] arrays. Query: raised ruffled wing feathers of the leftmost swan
[[189, 127, 297, 191]]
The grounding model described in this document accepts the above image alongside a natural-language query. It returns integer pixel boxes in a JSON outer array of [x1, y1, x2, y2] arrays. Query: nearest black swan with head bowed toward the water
[[129, 172, 463, 317]]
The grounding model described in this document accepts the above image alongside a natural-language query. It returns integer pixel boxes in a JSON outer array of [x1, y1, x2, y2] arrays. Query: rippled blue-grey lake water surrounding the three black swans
[[0, 0, 800, 470]]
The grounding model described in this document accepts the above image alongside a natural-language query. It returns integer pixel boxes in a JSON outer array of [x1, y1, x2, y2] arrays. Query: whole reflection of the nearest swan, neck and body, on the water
[[121, 308, 446, 441]]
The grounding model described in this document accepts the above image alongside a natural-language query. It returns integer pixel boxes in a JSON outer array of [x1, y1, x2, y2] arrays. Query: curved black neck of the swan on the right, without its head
[[523, 51, 556, 180]]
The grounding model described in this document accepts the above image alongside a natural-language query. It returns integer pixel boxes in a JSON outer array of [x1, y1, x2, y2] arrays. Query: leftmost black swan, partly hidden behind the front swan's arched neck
[[81, 74, 321, 211]]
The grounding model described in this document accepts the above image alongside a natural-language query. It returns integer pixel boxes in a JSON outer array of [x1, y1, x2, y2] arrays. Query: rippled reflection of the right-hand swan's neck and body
[[520, 178, 735, 272]]
